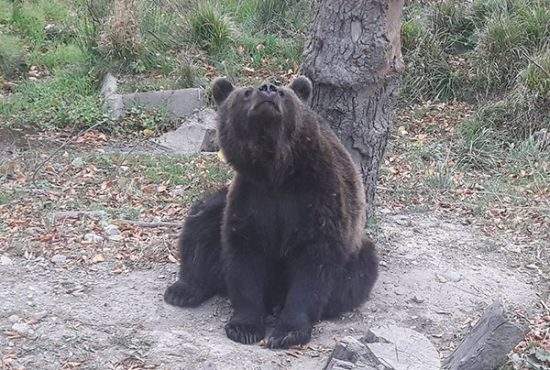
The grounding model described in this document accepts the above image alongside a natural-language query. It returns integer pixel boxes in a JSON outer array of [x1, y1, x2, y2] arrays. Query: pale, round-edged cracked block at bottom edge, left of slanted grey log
[[325, 325, 441, 370]]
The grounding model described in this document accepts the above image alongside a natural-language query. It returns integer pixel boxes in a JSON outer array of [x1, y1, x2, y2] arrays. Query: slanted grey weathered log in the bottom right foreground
[[444, 300, 526, 370]]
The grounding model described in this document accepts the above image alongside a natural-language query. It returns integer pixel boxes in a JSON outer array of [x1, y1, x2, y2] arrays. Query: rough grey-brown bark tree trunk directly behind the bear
[[301, 0, 404, 218]]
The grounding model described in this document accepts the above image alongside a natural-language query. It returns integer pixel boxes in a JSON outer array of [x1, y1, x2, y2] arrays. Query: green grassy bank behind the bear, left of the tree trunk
[[0, 0, 309, 131]]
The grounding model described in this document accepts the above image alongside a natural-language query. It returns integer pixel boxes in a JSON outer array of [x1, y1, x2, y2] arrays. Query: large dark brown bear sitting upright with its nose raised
[[164, 77, 378, 348]]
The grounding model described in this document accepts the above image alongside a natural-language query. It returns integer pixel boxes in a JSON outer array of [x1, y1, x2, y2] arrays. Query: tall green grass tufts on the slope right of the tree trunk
[[401, 0, 550, 173]]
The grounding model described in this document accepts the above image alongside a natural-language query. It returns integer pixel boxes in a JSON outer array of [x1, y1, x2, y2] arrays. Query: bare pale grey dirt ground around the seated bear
[[0, 210, 543, 369]]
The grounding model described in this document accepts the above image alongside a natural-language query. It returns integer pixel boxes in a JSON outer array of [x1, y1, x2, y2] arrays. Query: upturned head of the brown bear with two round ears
[[212, 76, 312, 181]]
